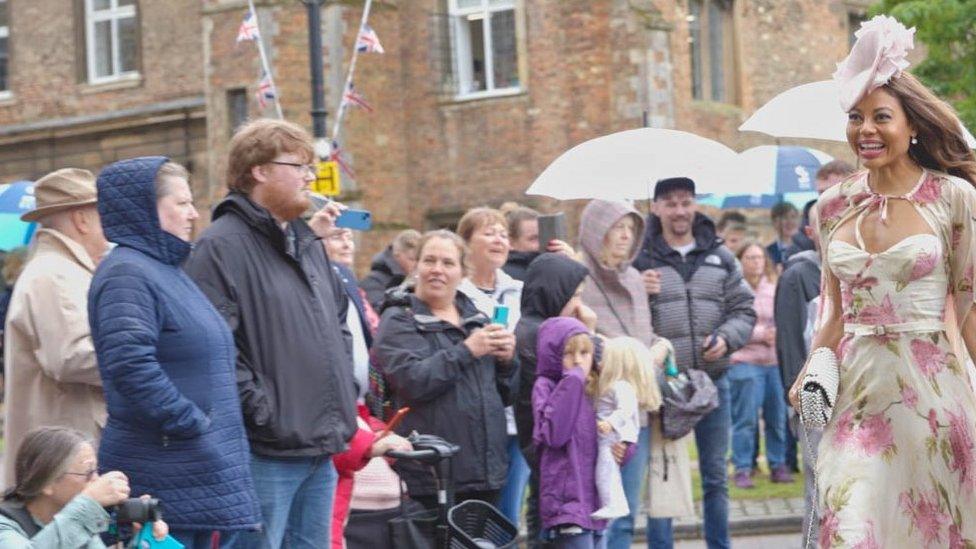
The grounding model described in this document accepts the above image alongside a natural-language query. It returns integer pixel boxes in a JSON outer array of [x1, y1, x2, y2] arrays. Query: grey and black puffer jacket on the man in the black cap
[[634, 213, 756, 379]]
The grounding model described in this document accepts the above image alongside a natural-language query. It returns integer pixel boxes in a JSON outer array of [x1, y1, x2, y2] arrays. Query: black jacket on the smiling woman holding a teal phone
[[373, 292, 517, 496]]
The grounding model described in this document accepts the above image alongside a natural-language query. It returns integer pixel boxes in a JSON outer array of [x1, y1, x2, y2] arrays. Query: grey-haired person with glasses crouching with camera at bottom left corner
[[0, 427, 169, 549]]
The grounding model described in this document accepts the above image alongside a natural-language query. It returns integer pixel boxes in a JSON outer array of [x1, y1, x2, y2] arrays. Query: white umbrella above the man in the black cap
[[525, 128, 738, 200]]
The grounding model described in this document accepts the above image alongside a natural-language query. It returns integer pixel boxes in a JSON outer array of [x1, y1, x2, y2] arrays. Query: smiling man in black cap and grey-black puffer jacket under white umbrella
[[628, 177, 756, 549]]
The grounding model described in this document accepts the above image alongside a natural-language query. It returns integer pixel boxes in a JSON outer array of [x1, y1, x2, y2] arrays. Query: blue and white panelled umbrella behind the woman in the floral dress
[[739, 145, 833, 194]]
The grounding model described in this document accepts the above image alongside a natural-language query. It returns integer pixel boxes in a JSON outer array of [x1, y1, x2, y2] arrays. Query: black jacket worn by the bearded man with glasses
[[184, 193, 356, 457]]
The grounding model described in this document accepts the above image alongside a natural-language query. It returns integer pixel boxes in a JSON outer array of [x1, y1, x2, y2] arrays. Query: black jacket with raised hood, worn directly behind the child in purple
[[515, 253, 589, 461]]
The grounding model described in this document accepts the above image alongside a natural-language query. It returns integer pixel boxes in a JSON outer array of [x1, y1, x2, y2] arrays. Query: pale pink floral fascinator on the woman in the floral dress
[[834, 15, 915, 112]]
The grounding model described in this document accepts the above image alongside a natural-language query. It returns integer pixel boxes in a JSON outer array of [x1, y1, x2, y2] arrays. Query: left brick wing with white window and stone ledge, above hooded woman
[[0, 0, 207, 196]]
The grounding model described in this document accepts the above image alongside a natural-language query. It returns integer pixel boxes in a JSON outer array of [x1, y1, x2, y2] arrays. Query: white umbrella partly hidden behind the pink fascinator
[[739, 80, 976, 148]]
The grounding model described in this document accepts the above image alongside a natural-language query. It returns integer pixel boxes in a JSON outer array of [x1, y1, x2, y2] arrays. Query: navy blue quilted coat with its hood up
[[88, 157, 261, 530]]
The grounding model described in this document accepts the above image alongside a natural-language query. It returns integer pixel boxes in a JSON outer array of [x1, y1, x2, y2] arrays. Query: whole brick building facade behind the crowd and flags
[[0, 0, 866, 270]]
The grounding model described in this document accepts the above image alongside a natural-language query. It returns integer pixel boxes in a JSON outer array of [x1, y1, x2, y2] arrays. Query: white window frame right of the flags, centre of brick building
[[448, 0, 522, 99]]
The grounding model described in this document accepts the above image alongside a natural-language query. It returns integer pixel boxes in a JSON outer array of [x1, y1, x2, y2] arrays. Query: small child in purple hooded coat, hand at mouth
[[532, 317, 607, 549]]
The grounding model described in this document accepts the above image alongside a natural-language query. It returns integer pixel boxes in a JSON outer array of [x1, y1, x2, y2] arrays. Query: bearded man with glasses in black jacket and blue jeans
[[185, 119, 356, 549]]
